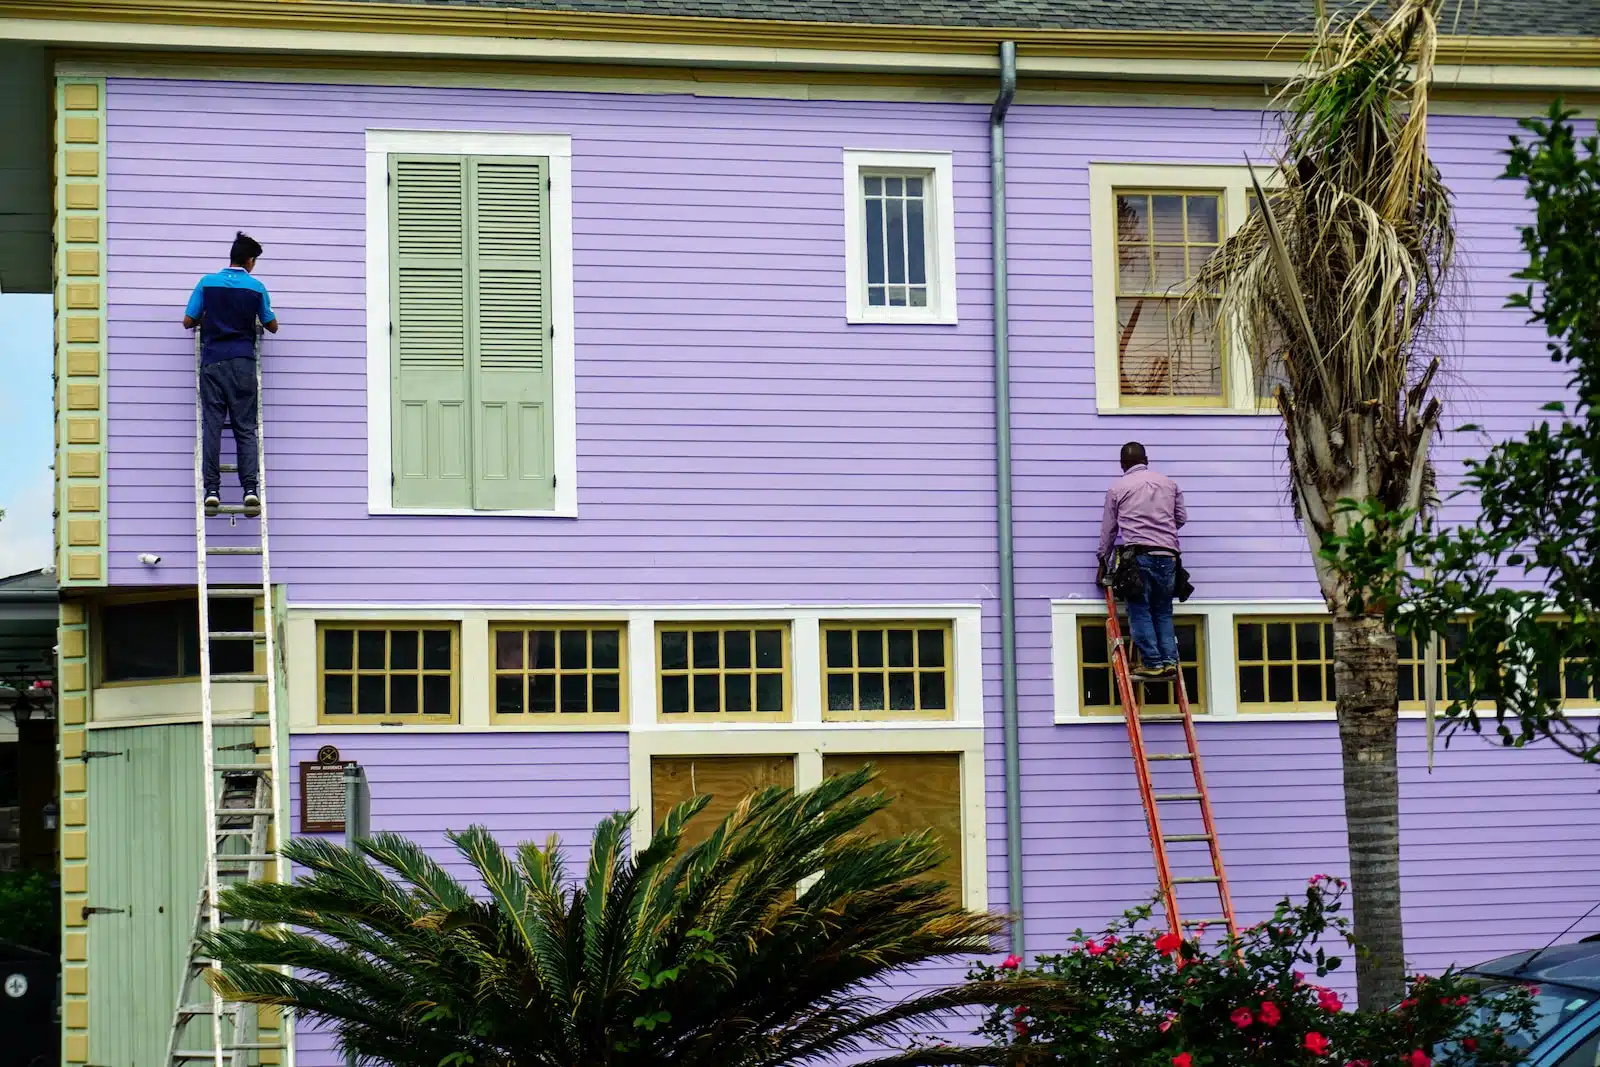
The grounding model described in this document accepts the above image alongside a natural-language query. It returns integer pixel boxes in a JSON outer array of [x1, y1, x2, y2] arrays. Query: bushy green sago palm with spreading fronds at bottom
[[196, 769, 1049, 1067]]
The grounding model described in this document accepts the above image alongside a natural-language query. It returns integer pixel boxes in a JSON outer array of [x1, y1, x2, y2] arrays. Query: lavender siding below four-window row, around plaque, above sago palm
[[290, 731, 629, 1067]]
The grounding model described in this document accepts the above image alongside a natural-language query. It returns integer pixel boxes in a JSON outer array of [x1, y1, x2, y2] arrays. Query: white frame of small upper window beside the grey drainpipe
[[845, 149, 955, 326]]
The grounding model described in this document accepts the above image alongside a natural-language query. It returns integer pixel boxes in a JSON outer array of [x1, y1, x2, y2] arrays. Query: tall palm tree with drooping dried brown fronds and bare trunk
[[1186, 0, 1454, 1006]]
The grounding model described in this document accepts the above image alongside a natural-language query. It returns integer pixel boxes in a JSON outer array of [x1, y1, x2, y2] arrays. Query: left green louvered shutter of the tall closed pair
[[389, 155, 472, 507]]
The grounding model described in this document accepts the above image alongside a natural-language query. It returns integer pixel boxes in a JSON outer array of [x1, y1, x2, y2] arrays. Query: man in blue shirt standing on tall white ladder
[[184, 232, 278, 515]]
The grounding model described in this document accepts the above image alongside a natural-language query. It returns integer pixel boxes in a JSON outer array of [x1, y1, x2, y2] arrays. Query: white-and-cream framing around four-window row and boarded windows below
[[283, 603, 989, 910]]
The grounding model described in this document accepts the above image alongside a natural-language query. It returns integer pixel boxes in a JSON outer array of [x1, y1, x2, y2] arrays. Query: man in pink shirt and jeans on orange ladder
[[1099, 442, 1189, 678]]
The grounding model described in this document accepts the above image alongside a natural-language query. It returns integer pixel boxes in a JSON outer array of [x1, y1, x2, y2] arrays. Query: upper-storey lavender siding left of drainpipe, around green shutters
[[107, 80, 994, 603]]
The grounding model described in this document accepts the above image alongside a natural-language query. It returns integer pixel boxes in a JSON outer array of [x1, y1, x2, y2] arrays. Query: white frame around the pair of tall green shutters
[[366, 130, 578, 518]]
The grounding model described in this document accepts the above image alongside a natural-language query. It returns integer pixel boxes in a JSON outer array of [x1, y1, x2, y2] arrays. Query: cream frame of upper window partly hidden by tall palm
[[1090, 163, 1278, 416]]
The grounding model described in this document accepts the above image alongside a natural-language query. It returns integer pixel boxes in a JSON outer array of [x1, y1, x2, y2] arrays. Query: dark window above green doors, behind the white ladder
[[99, 597, 252, 685]]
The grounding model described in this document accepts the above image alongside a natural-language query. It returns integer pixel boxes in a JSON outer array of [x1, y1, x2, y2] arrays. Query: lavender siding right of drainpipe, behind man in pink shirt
[[990, 106, 1600, 968]]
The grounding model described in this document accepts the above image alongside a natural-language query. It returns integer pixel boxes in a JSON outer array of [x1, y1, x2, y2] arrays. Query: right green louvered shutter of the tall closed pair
[[467, 157, 555, 510]]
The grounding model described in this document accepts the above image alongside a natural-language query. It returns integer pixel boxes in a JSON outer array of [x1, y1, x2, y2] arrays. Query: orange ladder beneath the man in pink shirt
[[1106, 589, 1238, 937]]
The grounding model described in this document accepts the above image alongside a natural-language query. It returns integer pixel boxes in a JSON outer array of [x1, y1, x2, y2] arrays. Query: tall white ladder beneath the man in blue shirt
[[166, 326, 288, 1067]]
